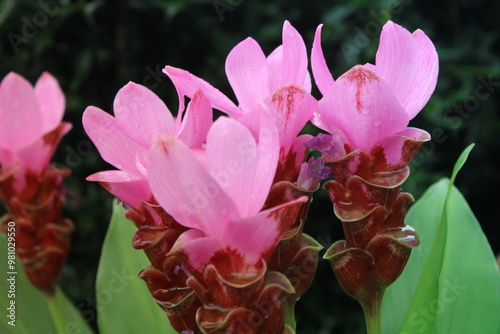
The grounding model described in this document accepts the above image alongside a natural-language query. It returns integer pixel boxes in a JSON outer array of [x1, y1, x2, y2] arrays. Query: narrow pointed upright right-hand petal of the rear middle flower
[[279, 21, 308, 90]]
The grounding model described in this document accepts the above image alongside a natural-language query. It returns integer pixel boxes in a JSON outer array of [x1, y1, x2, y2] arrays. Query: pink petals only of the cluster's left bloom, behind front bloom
[[83, 82, 212, 209]]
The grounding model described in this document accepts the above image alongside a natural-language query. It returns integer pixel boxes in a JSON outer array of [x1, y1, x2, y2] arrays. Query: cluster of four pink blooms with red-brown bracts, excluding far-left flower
[[83, 22, 437, 333]]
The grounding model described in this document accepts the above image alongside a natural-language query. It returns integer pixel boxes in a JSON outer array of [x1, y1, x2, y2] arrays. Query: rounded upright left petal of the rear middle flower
[[226, 37, 270, 111]]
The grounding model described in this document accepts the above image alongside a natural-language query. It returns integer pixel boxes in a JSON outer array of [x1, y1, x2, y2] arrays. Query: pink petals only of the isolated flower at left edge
[[0, 72, 71, 185]]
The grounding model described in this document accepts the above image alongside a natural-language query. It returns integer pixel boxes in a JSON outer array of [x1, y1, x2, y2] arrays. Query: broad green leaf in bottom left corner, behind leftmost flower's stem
[[0, 233, 92, 334]]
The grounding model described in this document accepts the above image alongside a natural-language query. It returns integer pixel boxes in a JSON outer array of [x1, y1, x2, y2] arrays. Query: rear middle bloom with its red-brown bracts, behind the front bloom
[[164, 21, 321, 324]]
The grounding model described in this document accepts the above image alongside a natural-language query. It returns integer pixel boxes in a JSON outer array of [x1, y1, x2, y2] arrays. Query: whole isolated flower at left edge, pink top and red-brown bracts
[[0, 72, 73, 295]]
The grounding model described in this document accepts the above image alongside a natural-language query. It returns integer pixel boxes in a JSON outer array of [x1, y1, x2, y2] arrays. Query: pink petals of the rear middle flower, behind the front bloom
[[164, 21, 317, 176]]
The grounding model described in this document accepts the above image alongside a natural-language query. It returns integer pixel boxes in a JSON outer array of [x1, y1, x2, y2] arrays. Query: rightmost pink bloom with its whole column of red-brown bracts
[[307, 21, 438, 324]]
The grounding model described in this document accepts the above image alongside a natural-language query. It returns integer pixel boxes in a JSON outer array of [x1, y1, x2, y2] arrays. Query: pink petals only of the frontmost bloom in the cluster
[[148, 114, 306, 279]]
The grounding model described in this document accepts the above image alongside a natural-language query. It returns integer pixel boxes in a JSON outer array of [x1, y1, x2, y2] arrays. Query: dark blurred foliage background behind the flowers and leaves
[[0, 0, 500, 334]]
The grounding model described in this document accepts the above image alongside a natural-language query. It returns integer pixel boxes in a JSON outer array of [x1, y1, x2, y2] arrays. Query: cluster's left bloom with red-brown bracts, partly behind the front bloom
[[83, 82, 212, 331]]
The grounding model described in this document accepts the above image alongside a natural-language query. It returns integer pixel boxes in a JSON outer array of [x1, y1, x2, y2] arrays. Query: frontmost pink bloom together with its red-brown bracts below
[[148, 111, 307, 333]]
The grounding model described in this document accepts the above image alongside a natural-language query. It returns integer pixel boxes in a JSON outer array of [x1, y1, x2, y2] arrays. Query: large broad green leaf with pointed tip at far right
[[382, 146, 500, 334]]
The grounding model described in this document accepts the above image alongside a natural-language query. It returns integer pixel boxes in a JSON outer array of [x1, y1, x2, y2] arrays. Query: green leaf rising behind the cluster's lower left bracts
[[96, 203, 176, 334]]
